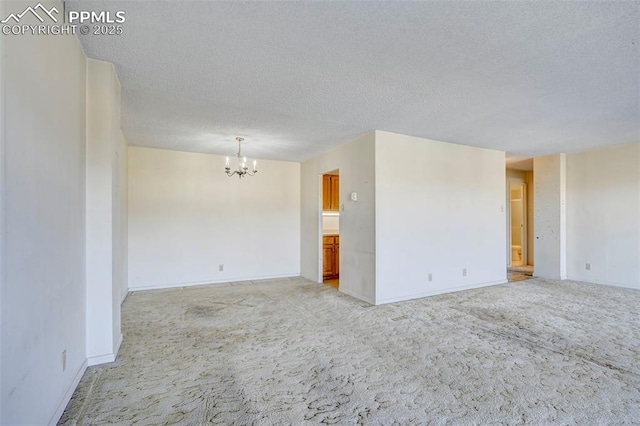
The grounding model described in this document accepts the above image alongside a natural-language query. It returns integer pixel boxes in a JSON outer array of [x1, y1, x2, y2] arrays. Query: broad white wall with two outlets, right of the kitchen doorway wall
[[375, 131, 506, 304]]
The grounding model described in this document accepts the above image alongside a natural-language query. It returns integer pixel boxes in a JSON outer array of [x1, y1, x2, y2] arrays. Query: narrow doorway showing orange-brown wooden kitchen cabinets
[[320, 170, 340, 289]]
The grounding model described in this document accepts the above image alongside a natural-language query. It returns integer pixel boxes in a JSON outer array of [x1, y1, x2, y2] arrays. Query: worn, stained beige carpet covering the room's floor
[[60, 278, 640, 425]]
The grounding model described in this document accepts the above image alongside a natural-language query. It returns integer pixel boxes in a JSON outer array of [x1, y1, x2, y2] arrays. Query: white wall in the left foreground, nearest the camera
[[0, 1, 86, 425]]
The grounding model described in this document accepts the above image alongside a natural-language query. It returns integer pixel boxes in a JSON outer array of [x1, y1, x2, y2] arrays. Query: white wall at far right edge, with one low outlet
[[567, 143, 640, 289]]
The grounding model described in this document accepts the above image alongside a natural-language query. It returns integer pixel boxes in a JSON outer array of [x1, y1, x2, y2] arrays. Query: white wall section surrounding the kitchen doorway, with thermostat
[[300, 132, 375, 304]]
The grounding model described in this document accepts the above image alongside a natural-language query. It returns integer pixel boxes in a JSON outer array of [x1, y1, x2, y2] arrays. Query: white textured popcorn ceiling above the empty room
[[66, 1, 640, 161]]
